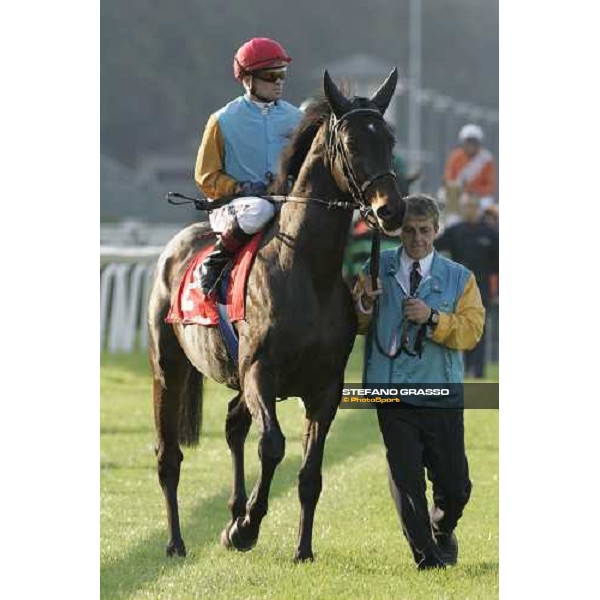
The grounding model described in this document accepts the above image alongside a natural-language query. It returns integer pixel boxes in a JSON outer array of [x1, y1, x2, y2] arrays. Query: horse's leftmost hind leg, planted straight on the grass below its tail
[[151, 334, 200, 556]]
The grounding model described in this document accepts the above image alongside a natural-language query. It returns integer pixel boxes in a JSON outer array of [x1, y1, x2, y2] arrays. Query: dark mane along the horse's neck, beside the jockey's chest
[[273, 97, 331, 194]]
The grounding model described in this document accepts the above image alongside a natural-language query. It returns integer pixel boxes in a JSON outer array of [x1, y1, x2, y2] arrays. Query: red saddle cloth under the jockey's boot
[[165, 231, 262, 325]]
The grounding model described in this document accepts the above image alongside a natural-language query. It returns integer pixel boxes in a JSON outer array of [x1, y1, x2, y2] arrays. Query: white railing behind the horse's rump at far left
[[100, 246, 162, 354]]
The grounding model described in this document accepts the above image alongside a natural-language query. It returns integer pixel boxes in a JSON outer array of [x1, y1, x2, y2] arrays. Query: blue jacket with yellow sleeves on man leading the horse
[[363, 246, 485, 405]]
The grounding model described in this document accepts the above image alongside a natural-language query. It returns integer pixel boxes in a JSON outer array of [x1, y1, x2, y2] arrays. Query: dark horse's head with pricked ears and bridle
[[323, 69, 404, 234]]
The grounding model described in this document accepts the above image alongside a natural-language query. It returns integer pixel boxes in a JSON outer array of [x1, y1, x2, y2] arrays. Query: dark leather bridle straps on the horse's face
[[326, 108, 396, 229]]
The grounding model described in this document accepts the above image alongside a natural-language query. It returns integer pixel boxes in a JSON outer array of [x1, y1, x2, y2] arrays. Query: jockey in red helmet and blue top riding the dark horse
[[195, 38, 302, 294]]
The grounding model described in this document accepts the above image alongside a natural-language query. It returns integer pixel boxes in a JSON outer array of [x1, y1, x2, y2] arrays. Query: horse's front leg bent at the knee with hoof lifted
[[229, 363, 285, 551]]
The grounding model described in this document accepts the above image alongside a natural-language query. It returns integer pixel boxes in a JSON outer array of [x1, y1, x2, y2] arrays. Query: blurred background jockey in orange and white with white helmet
[[444, 123, 495, 208]]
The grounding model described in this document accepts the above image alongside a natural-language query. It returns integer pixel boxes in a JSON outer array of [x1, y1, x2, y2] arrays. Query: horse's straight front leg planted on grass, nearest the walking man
[[294, 384, 342, 562]]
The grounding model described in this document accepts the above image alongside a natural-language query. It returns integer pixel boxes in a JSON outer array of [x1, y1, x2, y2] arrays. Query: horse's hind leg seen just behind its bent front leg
[[221, 393, 252, 548]]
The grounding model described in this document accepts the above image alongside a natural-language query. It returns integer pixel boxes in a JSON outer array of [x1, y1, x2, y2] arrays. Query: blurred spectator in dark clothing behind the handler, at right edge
[[435, 195, 498, 379]]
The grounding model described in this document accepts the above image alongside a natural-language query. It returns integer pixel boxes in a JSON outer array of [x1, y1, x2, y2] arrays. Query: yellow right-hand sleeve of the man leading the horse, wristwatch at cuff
[[431, 273, 485, 350]]
